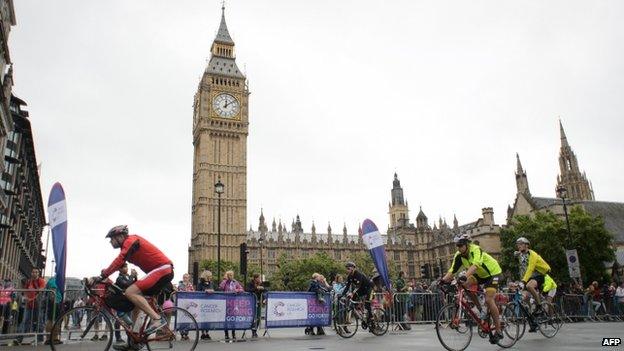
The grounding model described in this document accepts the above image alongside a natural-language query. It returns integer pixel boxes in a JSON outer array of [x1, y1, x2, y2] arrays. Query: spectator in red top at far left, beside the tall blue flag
[[16, 268, 46, 344]]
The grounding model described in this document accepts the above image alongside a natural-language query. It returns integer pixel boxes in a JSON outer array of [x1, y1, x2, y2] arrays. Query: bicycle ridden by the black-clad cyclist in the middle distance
[[333, 297, 390, 339]]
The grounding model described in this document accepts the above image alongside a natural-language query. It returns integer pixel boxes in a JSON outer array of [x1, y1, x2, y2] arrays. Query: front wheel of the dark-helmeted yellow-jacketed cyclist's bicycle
[[435, 304, 474, 351]]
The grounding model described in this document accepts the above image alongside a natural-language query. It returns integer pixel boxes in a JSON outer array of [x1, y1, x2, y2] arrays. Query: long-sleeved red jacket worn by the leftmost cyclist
[[102, 235, 172, 278]]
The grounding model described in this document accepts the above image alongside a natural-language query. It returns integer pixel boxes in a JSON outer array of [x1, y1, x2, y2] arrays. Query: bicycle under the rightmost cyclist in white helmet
[[507, 289, 563, 340]]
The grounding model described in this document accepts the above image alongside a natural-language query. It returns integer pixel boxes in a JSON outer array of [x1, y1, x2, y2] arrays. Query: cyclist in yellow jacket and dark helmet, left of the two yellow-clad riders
[[442, 234, 503, 344]]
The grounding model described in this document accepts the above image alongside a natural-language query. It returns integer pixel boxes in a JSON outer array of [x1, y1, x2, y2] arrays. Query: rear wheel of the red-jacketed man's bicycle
[[146, 307, 199, 351]]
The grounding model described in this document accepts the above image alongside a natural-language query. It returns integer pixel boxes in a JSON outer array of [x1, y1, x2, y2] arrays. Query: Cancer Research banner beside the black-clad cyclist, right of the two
[[265, 292, 331, 328]]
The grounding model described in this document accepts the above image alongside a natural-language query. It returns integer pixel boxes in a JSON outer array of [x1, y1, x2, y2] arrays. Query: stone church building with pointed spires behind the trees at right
[[507, 121, 624, 253]]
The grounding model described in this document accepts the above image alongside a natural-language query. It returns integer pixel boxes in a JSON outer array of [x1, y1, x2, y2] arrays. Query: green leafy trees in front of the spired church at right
[[501, 206, 615, 284]]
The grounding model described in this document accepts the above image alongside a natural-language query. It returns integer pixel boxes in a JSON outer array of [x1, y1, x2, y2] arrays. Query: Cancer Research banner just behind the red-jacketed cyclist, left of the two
[[176, 292, 256, 330]]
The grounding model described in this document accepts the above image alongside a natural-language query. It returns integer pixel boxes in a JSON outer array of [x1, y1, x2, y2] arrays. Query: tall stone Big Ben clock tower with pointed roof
[[189, 7, 249, 279]]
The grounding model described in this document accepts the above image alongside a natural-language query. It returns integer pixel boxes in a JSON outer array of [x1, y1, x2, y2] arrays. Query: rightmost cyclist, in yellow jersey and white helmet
[[516, 237, 556, 309]]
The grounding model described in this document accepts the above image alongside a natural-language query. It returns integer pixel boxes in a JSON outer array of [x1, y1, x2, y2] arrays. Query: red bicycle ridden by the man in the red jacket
[[50, 278, 199, 351]]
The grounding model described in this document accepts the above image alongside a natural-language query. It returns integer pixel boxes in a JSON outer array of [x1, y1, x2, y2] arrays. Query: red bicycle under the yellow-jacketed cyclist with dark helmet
[[435, 280, 518, 351]]
